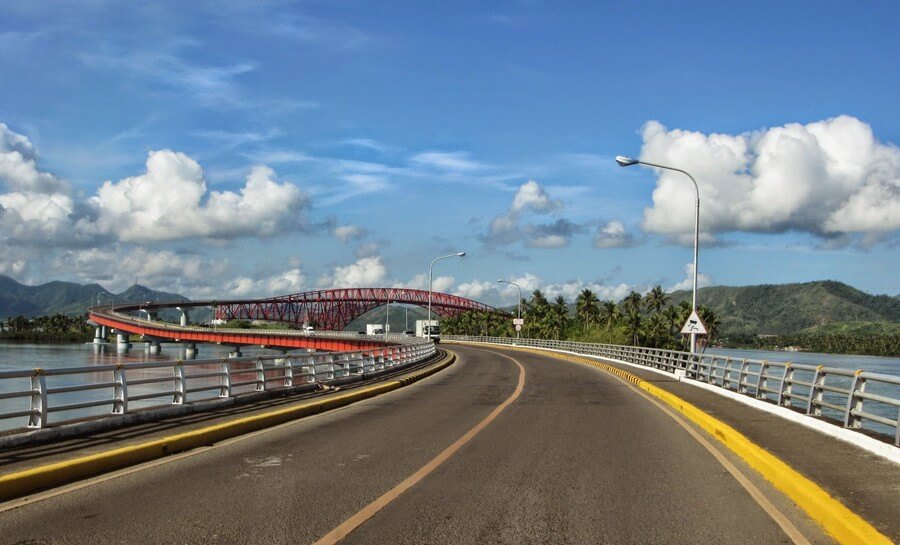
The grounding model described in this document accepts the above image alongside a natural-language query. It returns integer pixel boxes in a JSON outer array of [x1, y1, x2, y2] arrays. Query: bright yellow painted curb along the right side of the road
[[460, 343, 892, 545]]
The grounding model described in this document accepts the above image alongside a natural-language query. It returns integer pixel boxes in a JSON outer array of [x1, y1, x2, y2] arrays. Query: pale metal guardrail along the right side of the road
[[442, 335, 900, 446]]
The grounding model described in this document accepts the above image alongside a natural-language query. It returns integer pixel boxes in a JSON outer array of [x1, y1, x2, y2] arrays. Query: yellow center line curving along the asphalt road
[[314, 351, 525, 545]]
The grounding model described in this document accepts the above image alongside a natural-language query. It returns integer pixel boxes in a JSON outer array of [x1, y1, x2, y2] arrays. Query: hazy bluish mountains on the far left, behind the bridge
[[0, 275, 188, 319]]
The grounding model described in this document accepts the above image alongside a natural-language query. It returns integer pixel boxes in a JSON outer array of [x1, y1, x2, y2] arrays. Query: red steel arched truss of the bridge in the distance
[[215, 288, 502, 331]]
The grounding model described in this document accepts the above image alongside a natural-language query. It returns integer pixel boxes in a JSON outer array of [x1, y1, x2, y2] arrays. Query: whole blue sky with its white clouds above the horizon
[[0, 0, 900, 304]]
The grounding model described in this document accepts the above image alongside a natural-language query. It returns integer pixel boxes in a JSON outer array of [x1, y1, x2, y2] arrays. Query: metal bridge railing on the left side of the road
[[0, 340, 435, 429]]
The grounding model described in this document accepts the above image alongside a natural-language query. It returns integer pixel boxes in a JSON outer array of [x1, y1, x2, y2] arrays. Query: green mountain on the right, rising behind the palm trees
[[669, 280, 900, 335]]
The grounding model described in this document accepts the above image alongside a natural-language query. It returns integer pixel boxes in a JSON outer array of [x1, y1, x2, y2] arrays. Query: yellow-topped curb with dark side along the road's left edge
[[0, 351, 456, 501]]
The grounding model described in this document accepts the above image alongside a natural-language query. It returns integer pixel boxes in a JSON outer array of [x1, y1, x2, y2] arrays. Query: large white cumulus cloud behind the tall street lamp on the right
[[641, 115, 900, 243]]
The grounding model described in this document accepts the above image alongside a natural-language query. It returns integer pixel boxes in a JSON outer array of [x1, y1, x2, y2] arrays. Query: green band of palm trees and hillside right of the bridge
[[442, 282, 900, 356]]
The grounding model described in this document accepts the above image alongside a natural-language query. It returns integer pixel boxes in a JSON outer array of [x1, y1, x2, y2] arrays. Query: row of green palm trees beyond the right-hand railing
[[441, 286, 720, 350]]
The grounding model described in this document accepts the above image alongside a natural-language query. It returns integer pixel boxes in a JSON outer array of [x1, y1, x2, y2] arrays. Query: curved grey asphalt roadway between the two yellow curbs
[[0, 347, 828, 544]]
